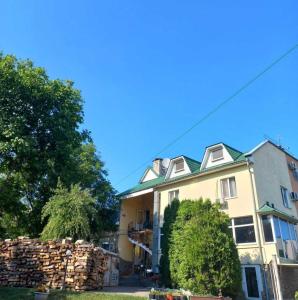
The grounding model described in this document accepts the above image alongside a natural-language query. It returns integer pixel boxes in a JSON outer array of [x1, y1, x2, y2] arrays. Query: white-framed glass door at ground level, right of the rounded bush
[[242, 265, 263, 300]]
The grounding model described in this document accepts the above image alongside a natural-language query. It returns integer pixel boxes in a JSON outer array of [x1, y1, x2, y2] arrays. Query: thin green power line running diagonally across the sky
[[117, 44, 298, 184]]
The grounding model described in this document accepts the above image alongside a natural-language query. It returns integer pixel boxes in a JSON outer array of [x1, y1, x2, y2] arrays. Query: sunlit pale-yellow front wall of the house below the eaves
[[157, 164, 261, 263]]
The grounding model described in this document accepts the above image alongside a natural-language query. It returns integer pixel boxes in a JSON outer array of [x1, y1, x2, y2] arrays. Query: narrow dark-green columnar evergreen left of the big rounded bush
[[160, 199, 180, 287]]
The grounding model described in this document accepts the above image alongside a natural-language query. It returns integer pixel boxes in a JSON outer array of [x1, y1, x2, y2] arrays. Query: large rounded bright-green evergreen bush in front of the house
[[169, 199, 241, 296]]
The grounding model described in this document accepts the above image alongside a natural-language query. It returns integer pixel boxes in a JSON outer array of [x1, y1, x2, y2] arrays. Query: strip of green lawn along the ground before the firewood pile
[[0, 288, 146, 300]]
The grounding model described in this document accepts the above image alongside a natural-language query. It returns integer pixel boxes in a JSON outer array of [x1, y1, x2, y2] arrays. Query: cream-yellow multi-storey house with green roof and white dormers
[[118, 140, 298, 299]]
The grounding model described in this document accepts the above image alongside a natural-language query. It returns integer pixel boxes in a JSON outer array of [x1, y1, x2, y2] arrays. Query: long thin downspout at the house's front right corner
[[246, 158, 270, 300]]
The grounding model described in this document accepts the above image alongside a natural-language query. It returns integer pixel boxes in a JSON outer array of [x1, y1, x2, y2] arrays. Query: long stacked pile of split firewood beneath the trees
[[0, 237, 108, 291]]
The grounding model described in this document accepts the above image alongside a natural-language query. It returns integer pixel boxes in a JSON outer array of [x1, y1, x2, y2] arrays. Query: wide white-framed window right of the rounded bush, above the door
[[230, 216, 256, 244]]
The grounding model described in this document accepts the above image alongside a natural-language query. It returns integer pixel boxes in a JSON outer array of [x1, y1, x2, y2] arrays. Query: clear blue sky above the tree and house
[[0, 0, 298, 191]]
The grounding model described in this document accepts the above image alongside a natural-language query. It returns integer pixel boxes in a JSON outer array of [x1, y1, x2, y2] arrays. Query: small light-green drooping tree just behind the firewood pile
[[41, 182, 96, 240]]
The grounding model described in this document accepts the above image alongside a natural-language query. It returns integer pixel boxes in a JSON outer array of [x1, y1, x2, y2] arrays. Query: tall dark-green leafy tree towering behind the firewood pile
[[0, 54, 117, 236]]
